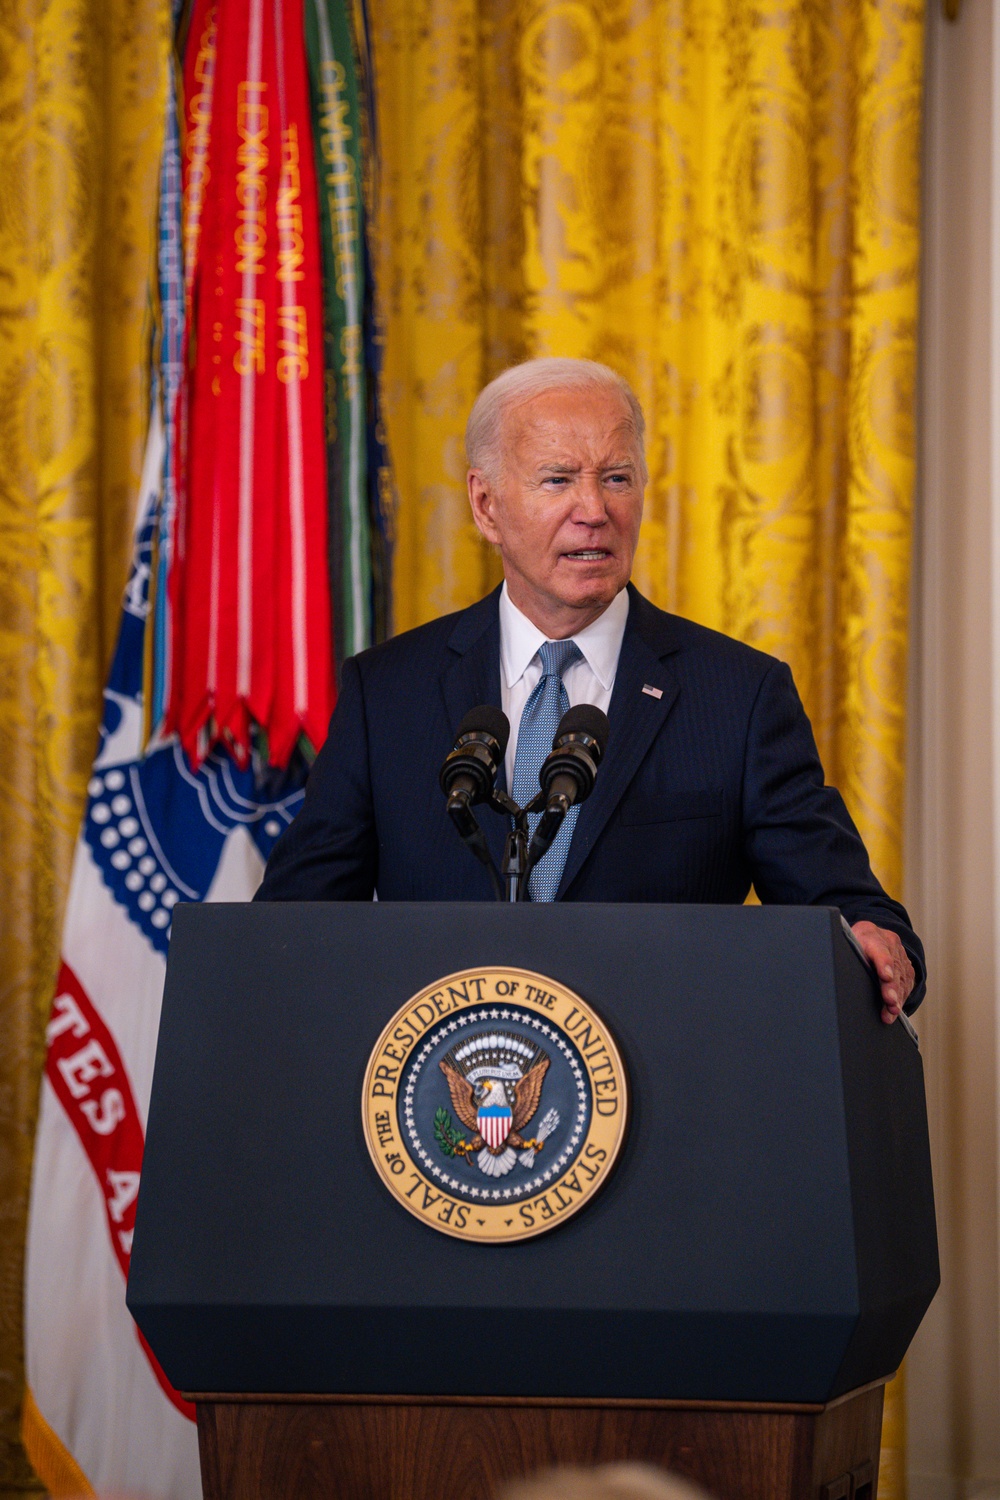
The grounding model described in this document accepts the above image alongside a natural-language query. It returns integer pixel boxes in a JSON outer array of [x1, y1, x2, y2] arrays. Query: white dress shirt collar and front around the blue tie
[[499, 584, 628, 791]]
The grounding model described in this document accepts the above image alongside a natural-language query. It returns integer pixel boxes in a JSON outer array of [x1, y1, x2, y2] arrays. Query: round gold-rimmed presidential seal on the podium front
[[363, 968, 628, 1244]]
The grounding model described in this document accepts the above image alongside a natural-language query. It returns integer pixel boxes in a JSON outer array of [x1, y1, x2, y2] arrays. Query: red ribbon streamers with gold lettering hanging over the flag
[[166, 0, 336, 765]]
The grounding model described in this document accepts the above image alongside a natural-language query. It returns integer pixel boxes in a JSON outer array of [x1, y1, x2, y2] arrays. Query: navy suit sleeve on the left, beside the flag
[[255, 657, 378, 902]]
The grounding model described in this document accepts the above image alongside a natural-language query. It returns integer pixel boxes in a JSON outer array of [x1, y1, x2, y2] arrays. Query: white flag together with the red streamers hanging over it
[[22, 0, 355, 1500]]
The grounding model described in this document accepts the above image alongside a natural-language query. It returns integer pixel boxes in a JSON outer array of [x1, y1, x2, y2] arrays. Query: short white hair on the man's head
[[465, 359, 646, 482]]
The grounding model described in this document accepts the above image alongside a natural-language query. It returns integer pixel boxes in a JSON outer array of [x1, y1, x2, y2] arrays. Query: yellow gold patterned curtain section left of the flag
[[0, 0, 169, 1494]]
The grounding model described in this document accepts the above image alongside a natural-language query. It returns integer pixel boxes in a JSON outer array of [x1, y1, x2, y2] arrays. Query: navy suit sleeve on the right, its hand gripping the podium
[[744, 662, 927, 1013]]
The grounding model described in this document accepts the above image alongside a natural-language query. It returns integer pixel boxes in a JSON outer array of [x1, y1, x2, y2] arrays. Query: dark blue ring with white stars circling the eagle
[[400, 1005, 589, 1203]]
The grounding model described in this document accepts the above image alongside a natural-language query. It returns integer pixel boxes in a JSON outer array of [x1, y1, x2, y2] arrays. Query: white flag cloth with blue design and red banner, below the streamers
[[22, 420, 301, 1500]]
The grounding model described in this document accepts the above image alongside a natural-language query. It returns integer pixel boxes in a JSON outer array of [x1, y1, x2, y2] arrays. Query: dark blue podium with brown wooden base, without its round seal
[[127, 903, 939, 1500]]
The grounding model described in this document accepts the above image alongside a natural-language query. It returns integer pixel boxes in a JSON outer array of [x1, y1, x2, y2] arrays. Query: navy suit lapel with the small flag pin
[[556, 585, 681, 900]]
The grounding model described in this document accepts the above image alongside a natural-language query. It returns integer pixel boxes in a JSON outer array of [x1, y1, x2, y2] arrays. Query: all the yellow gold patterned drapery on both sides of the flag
[[0, 0, 922, 1500]]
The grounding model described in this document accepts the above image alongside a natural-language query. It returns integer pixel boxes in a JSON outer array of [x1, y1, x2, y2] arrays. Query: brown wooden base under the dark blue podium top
[[190, 1382, 885, 1500]]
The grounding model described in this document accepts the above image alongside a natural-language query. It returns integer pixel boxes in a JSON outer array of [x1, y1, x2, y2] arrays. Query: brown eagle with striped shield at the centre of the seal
[[435, 1031, 559, 1178]]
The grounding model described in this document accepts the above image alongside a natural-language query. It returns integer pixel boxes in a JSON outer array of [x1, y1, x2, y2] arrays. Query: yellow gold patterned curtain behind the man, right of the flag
[[370, 0, 924, 1482]]
